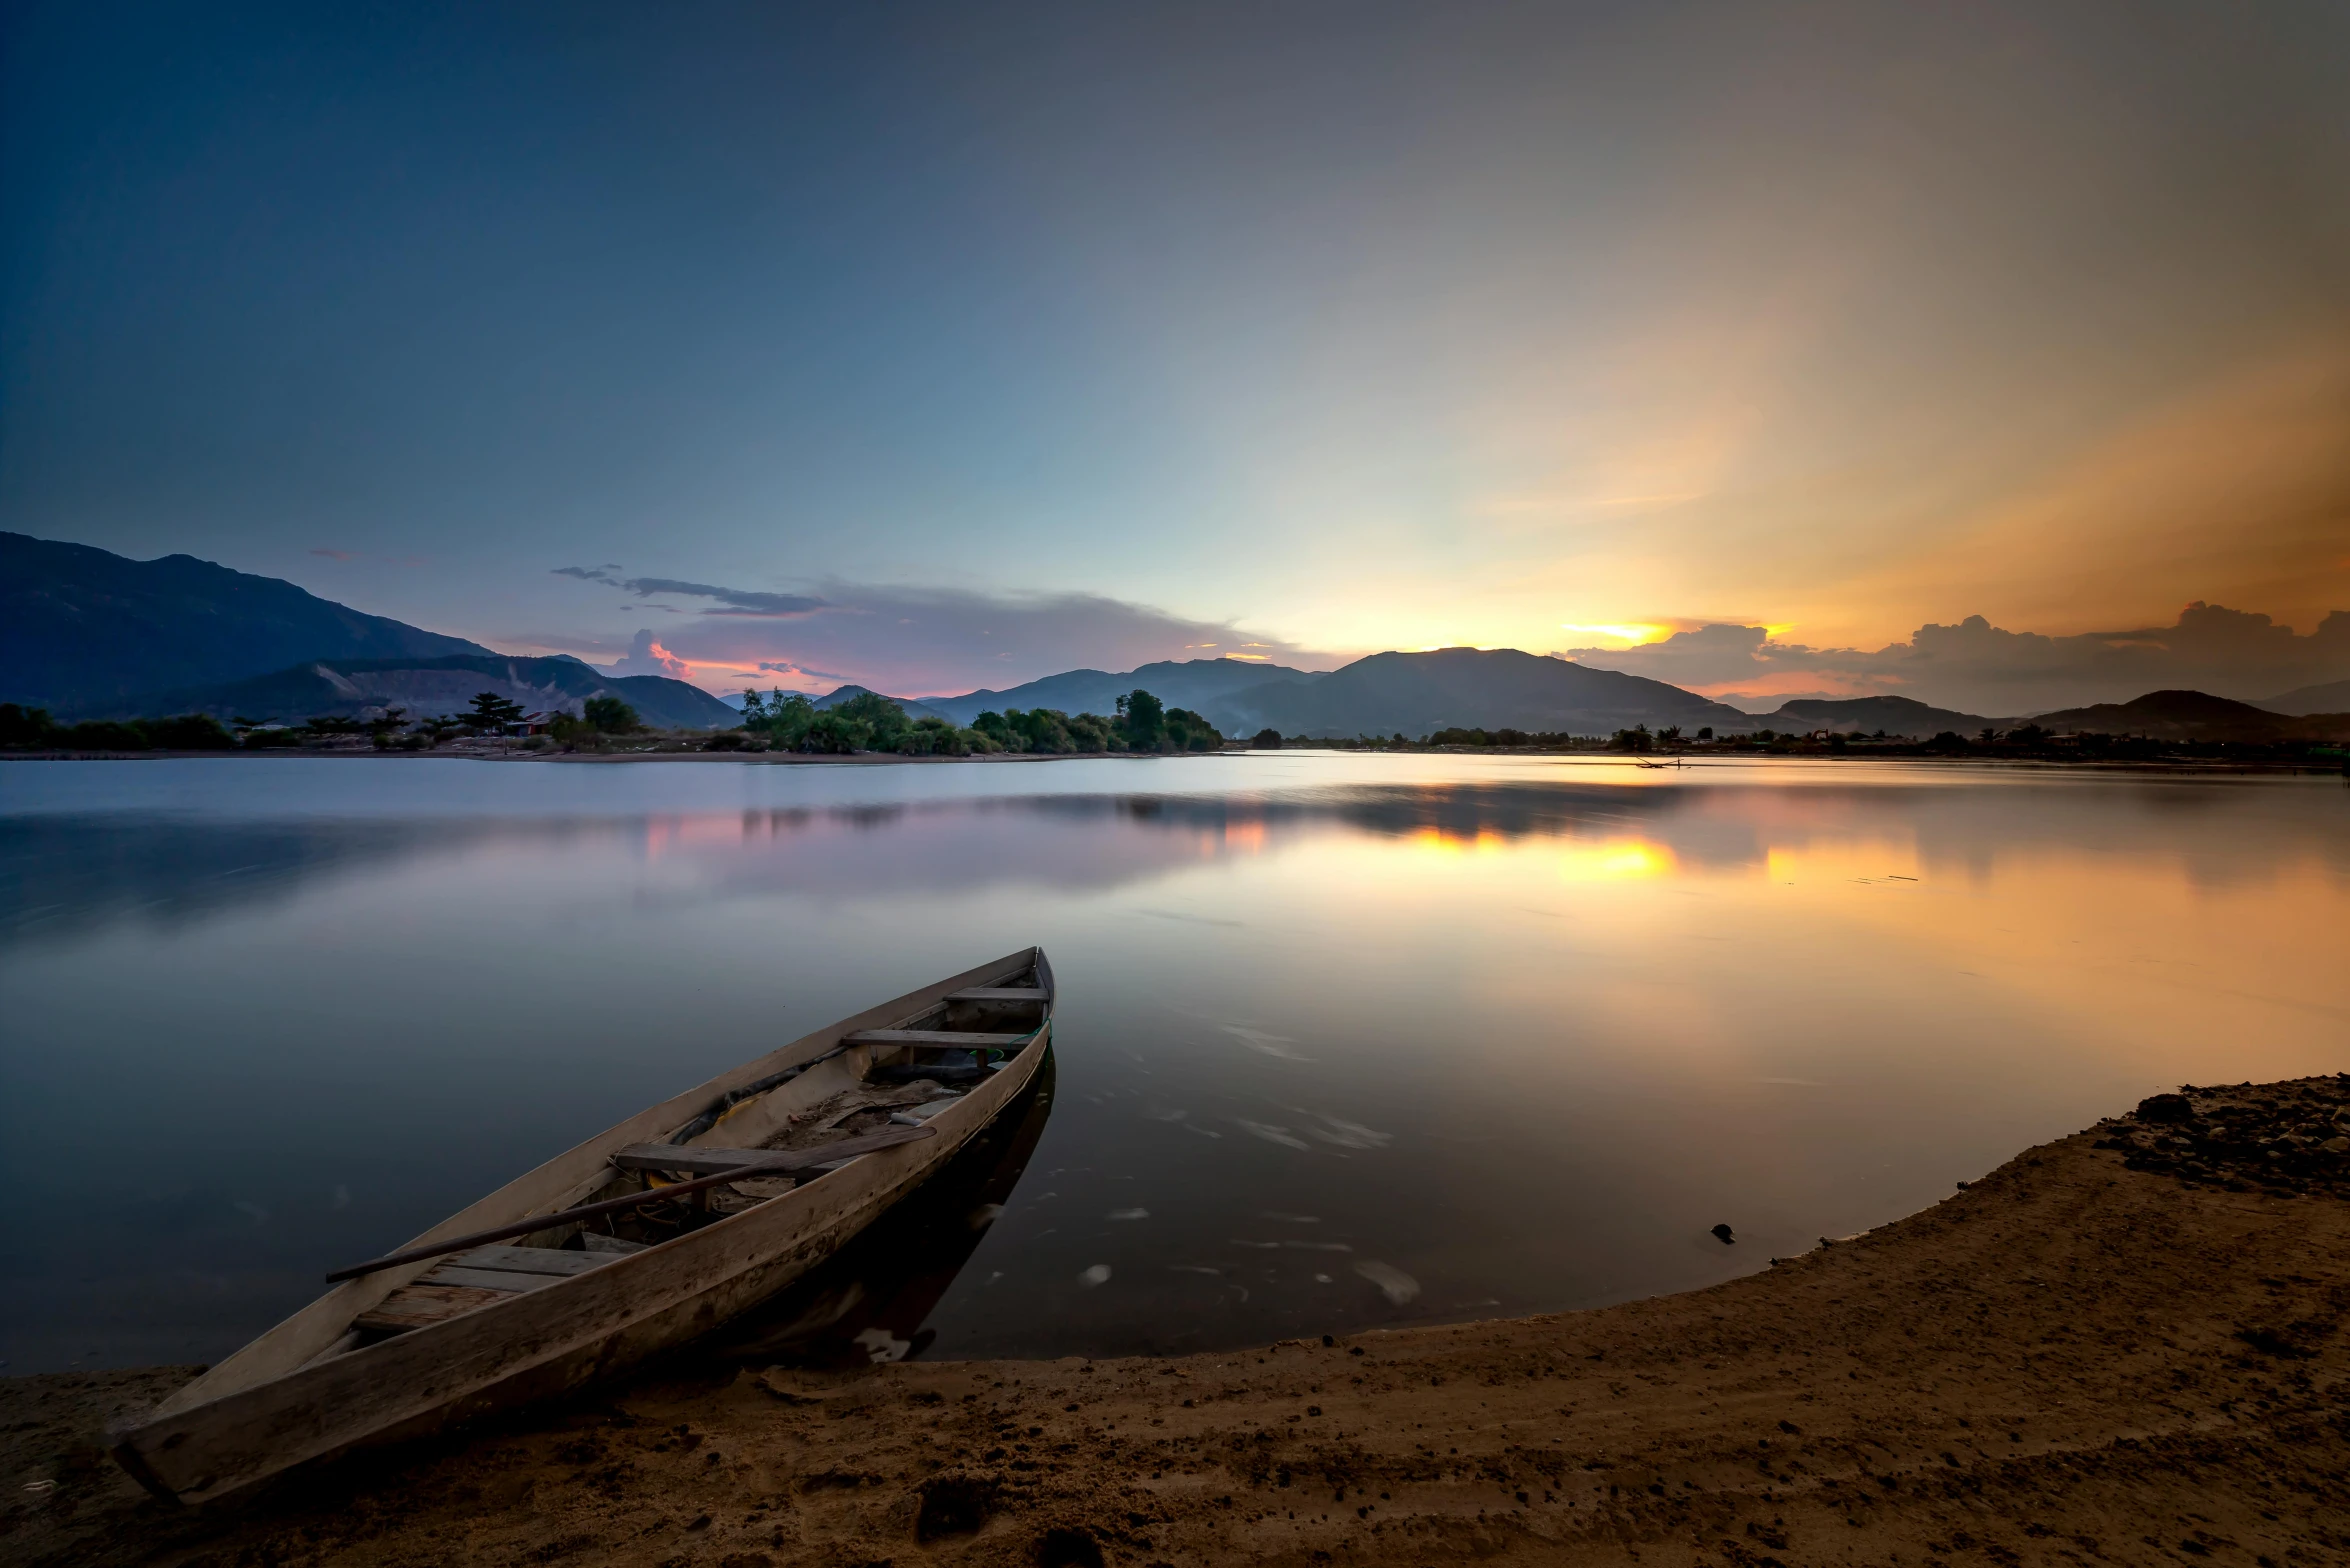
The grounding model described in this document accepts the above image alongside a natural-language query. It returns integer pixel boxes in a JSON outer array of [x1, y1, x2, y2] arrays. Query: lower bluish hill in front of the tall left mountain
[[99, 654, 743, 729]]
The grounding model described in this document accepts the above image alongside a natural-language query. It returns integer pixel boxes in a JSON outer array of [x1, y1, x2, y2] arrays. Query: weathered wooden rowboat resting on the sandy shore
[[115, 947, 1053, 1502]]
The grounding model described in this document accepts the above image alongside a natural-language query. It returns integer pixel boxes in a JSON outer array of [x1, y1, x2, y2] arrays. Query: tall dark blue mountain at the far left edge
[[0, 534, 489, 715]]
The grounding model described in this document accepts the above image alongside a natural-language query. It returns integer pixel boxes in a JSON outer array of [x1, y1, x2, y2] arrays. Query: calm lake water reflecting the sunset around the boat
[[0, 752, 2350, 1373]]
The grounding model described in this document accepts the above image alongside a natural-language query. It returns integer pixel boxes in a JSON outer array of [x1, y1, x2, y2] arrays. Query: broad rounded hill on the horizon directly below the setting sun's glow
[[1222, 649, 1763, 736]]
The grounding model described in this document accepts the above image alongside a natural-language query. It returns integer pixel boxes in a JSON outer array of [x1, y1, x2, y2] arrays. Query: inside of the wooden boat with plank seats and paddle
[[327, 952, 1053, 1354]]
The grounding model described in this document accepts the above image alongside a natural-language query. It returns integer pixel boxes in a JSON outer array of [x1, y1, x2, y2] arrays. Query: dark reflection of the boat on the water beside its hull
[[700, 1051, 1055, 1368]]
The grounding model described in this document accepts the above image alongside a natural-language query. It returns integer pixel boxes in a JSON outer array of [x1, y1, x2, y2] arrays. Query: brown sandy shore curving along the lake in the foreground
[[0, 1079, 2350, 1568]]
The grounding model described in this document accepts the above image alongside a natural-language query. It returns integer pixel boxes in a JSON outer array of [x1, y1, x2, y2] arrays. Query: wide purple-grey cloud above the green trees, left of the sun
[[557, 567, 1335, 696]]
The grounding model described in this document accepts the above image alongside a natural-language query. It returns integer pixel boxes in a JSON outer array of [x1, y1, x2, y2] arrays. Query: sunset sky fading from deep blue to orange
[[0, 0, 2350, 712]]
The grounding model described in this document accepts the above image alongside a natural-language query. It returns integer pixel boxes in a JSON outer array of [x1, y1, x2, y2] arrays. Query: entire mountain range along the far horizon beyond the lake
[[0, 534, 2350, 741]]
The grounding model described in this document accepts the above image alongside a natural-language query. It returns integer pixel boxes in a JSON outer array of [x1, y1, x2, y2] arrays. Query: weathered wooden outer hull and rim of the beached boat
[[115, 959, 1050, 1502]]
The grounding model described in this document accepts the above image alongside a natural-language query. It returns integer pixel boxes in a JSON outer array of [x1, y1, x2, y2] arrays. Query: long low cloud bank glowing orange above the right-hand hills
[[1567, 599, 2350, 717]]
